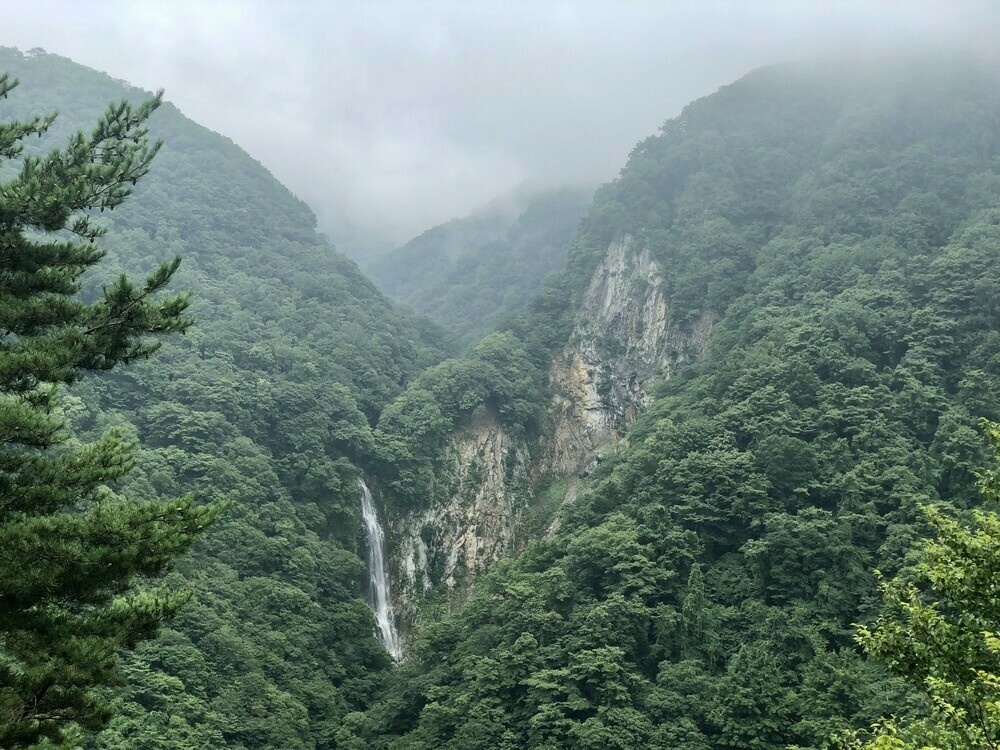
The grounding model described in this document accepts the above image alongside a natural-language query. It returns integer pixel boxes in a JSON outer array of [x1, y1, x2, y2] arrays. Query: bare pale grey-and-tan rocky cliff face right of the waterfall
[[395, 235, 713, 627]]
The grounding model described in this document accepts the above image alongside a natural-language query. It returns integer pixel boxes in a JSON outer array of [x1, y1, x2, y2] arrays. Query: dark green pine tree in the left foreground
[[0, 75, 217, 748]]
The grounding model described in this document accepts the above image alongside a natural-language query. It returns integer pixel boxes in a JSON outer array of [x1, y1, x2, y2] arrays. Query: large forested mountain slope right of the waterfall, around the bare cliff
[[352, 60, 1000, 750]]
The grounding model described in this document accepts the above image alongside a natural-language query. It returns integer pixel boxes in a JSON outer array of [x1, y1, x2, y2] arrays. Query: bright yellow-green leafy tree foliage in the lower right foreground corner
[[842, 423, 1000, 750]]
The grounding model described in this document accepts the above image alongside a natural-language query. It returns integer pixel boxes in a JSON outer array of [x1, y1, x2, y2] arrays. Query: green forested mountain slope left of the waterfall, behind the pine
[[0, 49, 445, 750]]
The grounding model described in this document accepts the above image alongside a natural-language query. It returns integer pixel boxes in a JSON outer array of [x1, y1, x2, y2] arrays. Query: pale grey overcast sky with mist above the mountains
[[0, 0, 1000, 250]]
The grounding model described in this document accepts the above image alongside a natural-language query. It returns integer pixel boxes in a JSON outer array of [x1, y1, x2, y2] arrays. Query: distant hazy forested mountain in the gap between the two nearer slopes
[[366, 188, 591, 344]]
